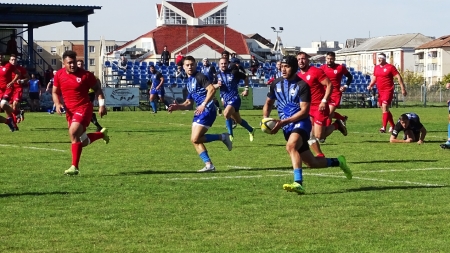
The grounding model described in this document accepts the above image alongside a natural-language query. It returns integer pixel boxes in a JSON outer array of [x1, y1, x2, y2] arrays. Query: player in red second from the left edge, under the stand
[[9, 55, 30, 123]]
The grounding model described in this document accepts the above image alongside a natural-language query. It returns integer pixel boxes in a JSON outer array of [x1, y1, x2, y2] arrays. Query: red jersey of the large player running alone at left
[[53, 68, 97, 111]]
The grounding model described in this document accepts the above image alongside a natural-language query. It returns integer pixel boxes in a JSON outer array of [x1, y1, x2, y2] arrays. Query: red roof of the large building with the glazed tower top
[[117, 25, 250, 54]]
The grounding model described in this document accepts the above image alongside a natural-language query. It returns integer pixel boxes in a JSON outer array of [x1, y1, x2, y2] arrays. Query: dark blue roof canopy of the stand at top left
[[0, 3, 101, 28]]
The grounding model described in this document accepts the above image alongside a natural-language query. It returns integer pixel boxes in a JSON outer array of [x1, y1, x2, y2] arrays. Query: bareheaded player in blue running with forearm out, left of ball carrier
[[169, 56, 232, 172]]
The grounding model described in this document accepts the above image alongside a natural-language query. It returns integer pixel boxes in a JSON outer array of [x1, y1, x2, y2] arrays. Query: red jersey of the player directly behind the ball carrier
[[297, 66, 327, 105]]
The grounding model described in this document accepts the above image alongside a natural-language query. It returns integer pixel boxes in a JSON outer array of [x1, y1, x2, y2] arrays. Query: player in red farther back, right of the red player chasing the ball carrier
[[320, 52, 353, 126]]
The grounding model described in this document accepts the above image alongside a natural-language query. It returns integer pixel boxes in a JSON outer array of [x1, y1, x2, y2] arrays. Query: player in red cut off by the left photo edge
[[0, 55, 20, 132]]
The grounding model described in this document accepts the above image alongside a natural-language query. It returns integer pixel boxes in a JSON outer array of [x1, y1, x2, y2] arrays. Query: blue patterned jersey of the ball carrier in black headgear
[[267, 76, 311, 130]]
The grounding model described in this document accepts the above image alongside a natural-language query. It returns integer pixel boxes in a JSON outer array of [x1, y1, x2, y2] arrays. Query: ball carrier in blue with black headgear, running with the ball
[[263, 56, 352, 194]]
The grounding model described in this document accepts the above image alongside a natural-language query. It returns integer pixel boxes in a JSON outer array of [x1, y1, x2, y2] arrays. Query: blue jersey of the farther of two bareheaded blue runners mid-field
[[216, 69, 247, 102]]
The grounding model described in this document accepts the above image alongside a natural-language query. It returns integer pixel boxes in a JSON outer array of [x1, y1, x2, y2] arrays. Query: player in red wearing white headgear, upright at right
[[367, 53, 407, 133]]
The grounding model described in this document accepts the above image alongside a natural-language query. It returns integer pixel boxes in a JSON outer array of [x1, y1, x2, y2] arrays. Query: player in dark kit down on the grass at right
[[389, 112, 427, 144]]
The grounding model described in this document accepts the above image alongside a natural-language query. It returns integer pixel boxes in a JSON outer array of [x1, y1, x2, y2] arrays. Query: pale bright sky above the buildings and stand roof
[[5, 0, 450, 47]]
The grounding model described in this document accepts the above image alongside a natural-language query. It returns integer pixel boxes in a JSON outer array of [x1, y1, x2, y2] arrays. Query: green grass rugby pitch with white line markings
[[0, 107, 450, 253]]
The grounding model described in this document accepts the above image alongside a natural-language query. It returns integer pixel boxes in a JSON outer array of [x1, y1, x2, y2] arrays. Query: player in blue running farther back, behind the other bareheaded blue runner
[[216, 58, 255, 141]]
